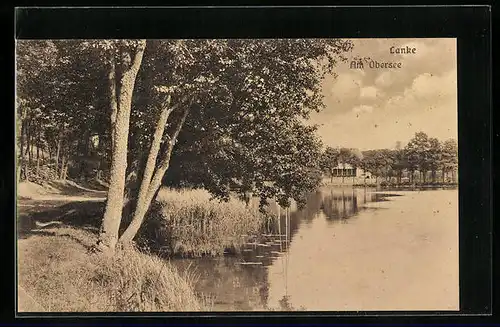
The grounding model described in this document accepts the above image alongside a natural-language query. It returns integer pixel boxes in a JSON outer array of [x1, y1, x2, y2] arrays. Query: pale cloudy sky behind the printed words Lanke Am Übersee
[[308, 38, 458, 150]]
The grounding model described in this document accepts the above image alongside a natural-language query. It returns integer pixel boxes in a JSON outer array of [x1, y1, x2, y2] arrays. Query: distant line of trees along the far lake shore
[[320, 132, 458, 184]]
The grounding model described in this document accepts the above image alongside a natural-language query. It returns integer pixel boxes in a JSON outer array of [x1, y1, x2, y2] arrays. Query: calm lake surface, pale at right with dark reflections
[[172, 187, 459, 311]]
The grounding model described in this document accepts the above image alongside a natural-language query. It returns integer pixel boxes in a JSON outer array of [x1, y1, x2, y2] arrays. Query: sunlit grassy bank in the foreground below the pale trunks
[[18, 228, 208, 312]]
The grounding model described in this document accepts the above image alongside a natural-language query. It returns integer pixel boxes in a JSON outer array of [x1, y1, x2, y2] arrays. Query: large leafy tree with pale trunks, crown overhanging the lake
[[81, 39, 352, 252]]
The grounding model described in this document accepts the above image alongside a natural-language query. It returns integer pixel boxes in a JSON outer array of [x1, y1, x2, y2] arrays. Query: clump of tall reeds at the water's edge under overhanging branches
[[140, 188, 266, 256]]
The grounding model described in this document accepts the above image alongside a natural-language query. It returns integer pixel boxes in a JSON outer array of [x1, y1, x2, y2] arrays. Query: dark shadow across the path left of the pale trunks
[[17, 201, 105, 239]]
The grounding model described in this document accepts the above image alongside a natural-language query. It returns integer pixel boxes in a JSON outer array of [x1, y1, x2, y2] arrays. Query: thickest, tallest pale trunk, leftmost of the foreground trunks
[[98, 40, 146, 253]]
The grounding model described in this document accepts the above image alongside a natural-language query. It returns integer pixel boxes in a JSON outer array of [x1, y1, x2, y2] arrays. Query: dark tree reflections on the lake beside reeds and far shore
[[172, 188, 402, 311]]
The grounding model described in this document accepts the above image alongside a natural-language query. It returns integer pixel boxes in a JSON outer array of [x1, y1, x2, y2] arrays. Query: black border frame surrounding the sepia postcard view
[[0, 6, 493, 325]]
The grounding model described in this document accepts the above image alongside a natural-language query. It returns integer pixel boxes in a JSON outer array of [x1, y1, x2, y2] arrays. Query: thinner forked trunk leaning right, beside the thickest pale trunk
[[120, 104, 191, 244]]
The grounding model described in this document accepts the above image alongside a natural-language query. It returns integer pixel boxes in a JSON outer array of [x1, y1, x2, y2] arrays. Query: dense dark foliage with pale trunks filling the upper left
[[17, 39, 352, 254]]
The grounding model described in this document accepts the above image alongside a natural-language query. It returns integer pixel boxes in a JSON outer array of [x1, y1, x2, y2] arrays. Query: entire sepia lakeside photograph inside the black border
[[15, 38, 465, 313]]
